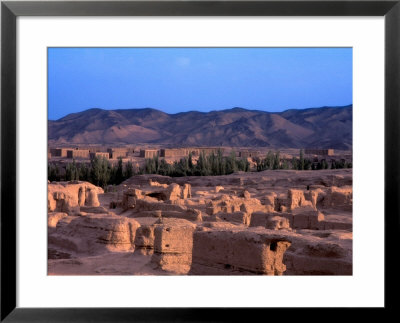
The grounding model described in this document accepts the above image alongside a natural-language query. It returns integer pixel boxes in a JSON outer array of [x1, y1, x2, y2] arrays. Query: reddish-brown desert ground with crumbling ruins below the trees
[[48, 169, 353, 275]]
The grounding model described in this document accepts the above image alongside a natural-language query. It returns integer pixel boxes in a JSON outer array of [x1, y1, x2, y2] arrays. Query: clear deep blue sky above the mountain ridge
[[48, 48, 353, 120]]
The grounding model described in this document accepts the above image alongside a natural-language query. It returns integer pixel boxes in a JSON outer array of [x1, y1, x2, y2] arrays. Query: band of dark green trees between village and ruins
[[48, 150, 352, 188]]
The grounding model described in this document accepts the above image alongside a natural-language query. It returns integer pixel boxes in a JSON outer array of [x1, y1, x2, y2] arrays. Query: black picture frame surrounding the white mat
[[0, 0, 400, 322]]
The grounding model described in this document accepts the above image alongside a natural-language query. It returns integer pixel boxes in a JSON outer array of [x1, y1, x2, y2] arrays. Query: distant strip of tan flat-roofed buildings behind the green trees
[[48, 146, 352, 170]]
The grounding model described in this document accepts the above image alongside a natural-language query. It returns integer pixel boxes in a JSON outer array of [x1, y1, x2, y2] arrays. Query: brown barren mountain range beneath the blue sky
[[48, 105, 353, 150]]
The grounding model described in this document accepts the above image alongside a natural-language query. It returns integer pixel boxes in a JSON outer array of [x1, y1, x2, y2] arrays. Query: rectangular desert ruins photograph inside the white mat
[[47, 47, 354, 276]]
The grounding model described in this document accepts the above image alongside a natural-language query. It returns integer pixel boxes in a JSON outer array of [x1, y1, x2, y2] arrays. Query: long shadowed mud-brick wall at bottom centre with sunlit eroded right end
[[190, 228, 290, 275]]
